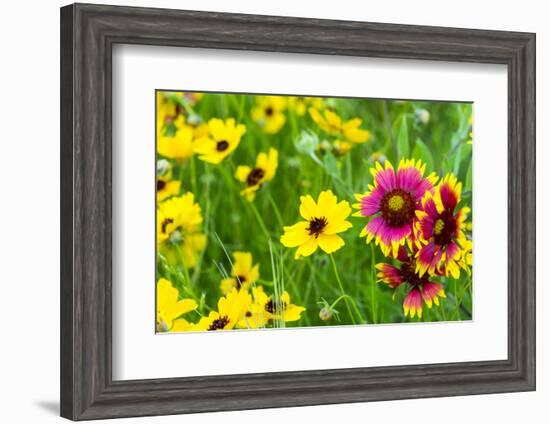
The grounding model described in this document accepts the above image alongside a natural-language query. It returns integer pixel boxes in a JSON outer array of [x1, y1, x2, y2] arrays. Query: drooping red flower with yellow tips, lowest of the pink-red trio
[[376, 247, 445, 318]]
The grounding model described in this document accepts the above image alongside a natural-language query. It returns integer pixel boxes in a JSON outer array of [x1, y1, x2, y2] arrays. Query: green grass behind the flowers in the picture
[[157, 93, 472, 327]]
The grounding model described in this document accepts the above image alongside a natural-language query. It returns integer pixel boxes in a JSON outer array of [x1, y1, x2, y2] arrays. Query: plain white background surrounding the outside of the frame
[[0, 0, 550, 424]]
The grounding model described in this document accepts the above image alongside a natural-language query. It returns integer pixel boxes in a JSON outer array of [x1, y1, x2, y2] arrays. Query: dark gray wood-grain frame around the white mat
[[61, 4, 535, 420]]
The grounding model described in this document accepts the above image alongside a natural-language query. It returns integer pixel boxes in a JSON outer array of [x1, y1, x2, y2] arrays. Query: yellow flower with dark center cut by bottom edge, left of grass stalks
[[193, 289, 252, 331]]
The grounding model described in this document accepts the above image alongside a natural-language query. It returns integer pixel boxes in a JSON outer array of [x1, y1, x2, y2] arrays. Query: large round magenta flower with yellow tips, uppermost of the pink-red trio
[[353, 159, 437, 256]]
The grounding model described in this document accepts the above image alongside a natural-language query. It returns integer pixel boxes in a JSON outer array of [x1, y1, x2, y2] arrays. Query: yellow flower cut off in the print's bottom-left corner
[[157, 278, 197, 332]]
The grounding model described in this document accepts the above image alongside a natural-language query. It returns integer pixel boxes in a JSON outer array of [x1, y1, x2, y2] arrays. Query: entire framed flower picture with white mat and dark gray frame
[[61, 4, 536, 420]]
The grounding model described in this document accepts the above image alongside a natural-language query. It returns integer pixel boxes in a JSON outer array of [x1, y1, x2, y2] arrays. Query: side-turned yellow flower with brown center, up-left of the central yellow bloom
[[235, 148, 278, 202]]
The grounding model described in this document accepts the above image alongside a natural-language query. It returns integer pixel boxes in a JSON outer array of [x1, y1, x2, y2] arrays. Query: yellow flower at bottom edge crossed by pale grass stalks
[[238, 286, 306, 328]]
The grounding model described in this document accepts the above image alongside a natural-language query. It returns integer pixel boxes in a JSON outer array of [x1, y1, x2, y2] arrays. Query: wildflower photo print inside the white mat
[[155, 91, 472, 332]]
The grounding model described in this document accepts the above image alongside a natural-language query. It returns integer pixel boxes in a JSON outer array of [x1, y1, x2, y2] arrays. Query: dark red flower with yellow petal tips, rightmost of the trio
[[415, 174, 471, 278]]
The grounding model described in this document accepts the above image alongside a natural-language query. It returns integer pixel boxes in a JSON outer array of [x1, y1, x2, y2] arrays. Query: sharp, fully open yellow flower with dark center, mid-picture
[[281, 190, 351, 259]]
